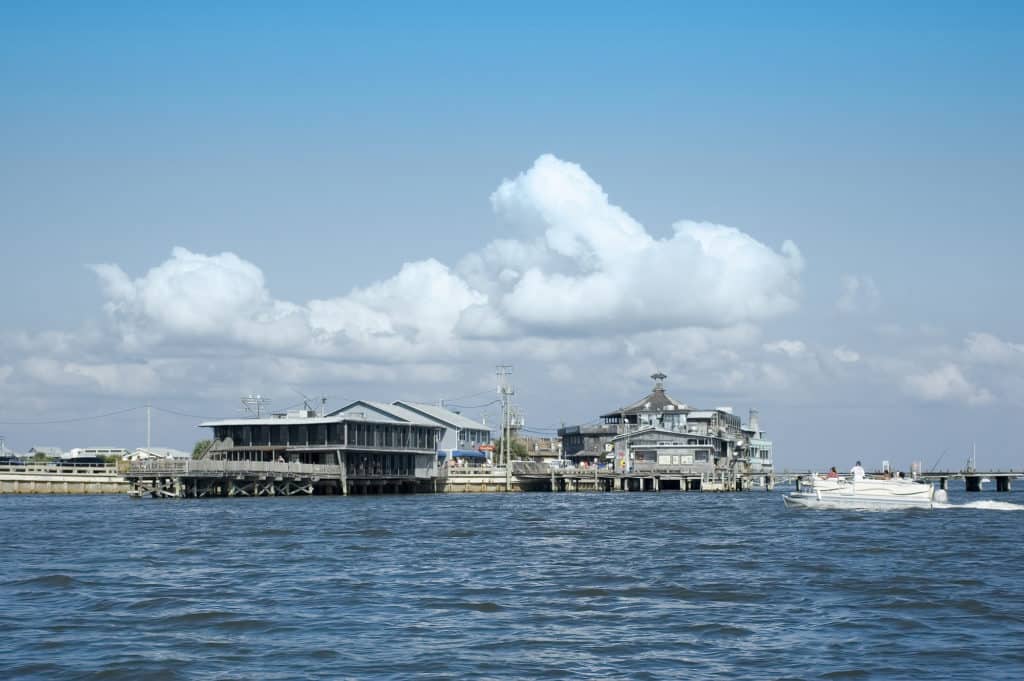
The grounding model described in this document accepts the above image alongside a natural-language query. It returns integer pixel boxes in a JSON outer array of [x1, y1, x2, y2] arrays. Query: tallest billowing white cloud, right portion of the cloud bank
[[473, 155, 803, 335]]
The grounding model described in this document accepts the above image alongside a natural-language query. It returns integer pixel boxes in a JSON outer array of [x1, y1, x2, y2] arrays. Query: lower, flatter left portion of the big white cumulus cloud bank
[[93, 248, 485, 357]]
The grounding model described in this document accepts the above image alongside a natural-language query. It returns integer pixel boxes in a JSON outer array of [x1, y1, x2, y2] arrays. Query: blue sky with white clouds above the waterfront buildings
[[0, 2, 1024, 469]]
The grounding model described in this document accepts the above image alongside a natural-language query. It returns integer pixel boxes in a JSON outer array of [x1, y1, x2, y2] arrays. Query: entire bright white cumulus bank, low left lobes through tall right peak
[[92, 155, 803, 361]]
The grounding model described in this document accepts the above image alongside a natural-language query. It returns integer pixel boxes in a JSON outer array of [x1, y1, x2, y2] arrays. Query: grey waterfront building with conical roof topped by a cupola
[[558, 373, 772, 485]]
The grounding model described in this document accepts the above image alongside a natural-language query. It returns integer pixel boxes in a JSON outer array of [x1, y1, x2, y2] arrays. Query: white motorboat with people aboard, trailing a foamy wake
[[782, 475, 948, 511]]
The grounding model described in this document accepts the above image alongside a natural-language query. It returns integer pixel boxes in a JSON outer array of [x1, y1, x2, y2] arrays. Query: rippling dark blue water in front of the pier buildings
[[0, 492, 1024, 679]]
